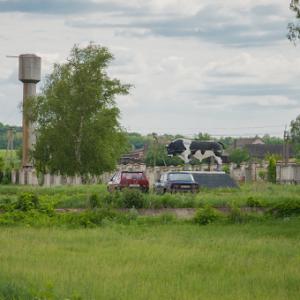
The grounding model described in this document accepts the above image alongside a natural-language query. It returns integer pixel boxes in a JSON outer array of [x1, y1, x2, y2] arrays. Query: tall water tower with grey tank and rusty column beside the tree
[[19, 54, 41, 169]]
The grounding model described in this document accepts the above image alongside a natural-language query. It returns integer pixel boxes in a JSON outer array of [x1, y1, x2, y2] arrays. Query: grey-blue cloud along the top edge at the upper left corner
[[0, 0, 128, 14]]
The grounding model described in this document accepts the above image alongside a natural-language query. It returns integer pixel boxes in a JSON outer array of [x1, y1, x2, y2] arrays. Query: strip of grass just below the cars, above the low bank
[[0, 183, 300, 208]]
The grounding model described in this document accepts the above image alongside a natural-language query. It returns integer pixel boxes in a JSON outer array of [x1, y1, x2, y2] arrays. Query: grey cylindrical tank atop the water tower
[[19, 54, 41, 83]]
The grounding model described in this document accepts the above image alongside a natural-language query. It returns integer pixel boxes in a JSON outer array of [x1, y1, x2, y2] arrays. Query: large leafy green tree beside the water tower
[[26, 43, 130, 175]]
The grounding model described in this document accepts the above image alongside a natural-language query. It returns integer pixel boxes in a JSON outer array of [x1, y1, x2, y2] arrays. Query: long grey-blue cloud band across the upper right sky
[[66, 5, 286, 47]]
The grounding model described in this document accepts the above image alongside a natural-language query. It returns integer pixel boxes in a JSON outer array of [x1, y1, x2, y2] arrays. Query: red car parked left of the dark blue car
[[107, 171, 149, 192]]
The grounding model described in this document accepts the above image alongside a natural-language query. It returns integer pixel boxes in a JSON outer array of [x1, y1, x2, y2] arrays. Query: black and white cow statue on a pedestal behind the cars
[[167, 139, 224, 168]]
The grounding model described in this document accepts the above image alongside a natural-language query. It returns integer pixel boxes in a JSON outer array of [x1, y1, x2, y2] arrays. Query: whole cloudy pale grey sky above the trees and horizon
[[0, 0, 300, 136]]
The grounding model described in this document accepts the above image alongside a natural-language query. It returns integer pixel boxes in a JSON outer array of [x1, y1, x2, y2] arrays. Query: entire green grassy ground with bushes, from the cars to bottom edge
[[0, 184, 300, 300]]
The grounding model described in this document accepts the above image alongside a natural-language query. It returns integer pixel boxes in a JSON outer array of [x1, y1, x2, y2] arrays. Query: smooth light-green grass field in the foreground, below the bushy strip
[[0, 218, 300, 300]]
